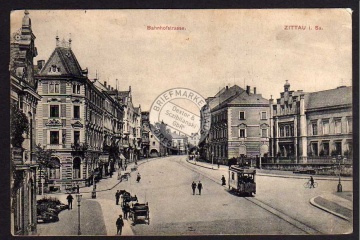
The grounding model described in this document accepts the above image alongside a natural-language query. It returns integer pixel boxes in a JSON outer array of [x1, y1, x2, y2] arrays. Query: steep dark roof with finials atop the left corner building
[[39, 47, 83, 77]]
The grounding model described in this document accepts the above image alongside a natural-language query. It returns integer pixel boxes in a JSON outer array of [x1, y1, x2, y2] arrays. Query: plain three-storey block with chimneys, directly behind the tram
[[205, 85, 270, 164]]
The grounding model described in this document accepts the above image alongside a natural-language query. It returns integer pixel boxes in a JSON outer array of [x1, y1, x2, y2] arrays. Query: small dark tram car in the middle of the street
[[228, 166, 256, 196]]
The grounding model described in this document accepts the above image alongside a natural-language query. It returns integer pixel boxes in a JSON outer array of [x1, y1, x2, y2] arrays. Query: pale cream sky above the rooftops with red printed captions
[[11, 9, 352, 111]]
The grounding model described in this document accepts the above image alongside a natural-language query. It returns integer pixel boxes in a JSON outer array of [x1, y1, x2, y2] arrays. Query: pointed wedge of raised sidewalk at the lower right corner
[[310, 192, 353, 221]]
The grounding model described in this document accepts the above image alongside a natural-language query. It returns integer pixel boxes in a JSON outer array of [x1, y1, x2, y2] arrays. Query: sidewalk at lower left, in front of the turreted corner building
[[36, 158, 156, 236]]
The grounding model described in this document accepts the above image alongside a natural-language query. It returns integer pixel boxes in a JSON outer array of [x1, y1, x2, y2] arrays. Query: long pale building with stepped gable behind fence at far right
[[270, 81, 352, 163]]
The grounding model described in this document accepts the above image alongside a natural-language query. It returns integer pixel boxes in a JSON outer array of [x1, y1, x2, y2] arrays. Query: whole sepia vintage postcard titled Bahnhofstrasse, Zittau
[[9, 8, 357, 236]]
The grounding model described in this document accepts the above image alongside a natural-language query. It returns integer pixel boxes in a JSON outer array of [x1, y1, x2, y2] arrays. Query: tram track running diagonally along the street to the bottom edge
[[177, 159, 324, 235]]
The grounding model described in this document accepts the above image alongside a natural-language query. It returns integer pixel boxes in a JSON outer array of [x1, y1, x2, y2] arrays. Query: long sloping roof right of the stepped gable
[[305, 86, 352, 110]]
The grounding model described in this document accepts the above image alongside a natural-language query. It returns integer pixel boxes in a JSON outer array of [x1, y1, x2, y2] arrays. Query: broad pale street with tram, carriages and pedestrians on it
[[39, 155, 352, 236]]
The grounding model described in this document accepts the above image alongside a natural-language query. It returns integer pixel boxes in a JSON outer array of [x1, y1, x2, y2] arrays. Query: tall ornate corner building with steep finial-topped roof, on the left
[[37, 37, 123, 191]]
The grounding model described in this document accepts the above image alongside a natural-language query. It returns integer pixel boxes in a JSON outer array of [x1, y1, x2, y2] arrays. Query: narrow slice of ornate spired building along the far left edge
[[10, 11, 41, 235]]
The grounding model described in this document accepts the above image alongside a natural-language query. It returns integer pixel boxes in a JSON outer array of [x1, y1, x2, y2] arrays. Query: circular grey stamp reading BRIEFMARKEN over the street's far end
[[149, 88, 211, 153]]
